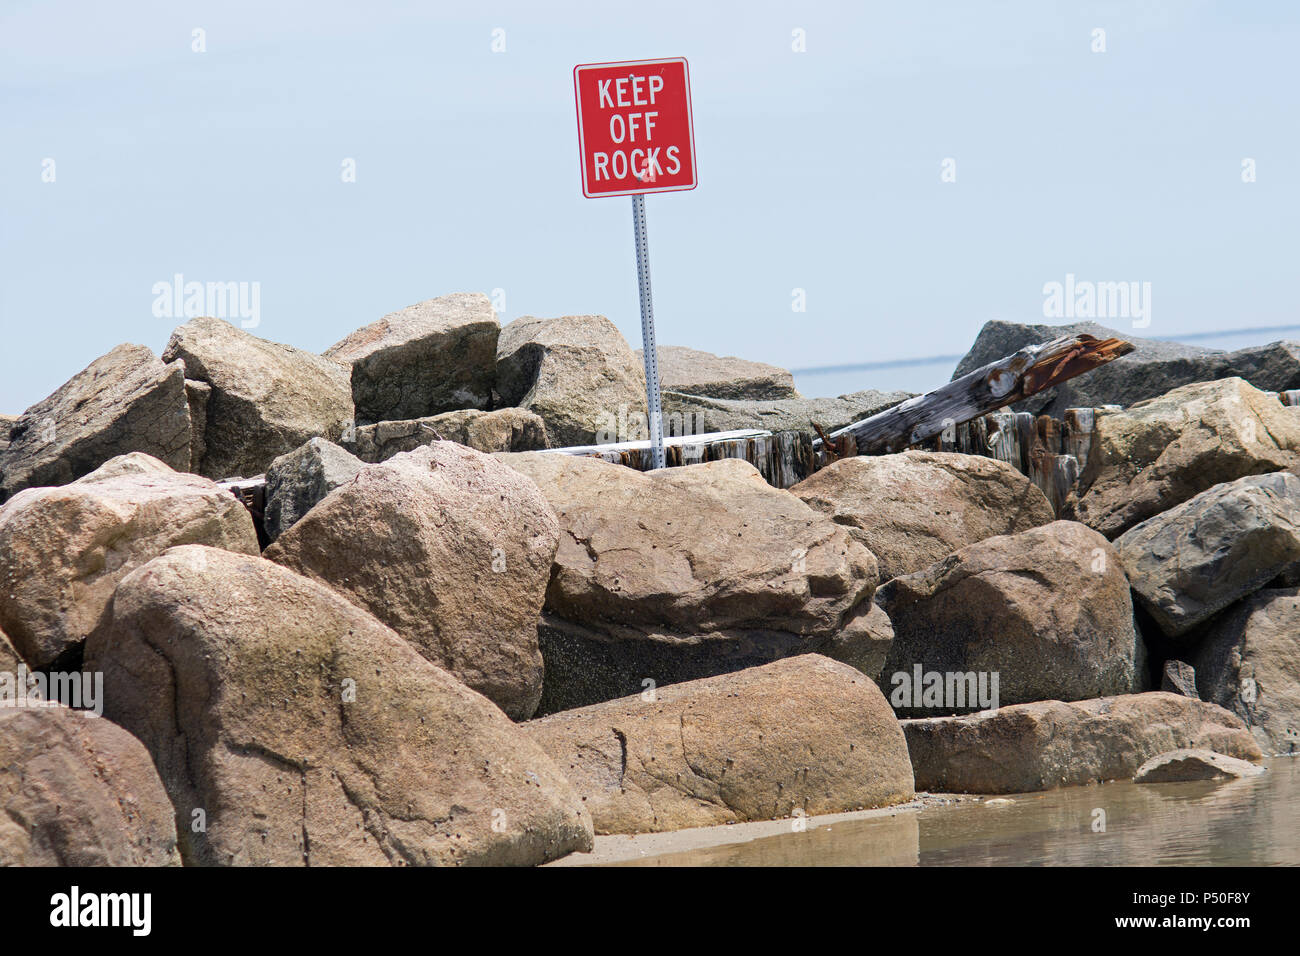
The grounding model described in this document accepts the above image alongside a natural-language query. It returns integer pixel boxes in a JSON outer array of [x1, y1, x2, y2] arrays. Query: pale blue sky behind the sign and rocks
[[0, 0, 1300, 414]]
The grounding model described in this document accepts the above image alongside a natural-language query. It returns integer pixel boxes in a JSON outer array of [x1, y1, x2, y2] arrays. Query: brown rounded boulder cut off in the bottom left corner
[[0, 706, 181, 866]]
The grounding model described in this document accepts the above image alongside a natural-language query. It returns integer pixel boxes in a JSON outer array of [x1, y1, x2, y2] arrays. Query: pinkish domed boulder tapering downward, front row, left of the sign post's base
[[267, 441, 559, 719]]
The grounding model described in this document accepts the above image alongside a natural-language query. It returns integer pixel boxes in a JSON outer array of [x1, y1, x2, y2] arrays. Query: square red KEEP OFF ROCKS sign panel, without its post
[[573, 57, 696, 198]]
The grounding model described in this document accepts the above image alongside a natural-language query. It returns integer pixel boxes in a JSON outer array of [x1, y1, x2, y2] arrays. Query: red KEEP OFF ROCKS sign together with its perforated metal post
[[573, 57, 696, 468]]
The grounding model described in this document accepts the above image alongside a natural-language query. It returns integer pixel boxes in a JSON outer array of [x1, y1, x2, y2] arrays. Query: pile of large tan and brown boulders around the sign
[[0, 308, 1300, 865]]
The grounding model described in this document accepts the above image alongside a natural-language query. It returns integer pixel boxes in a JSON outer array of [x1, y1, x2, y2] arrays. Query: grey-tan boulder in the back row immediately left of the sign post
[[497, 315, 646, 447]]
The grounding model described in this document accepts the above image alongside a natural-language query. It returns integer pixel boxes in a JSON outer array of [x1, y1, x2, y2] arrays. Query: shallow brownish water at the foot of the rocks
[[608, 758, 1300, 866]]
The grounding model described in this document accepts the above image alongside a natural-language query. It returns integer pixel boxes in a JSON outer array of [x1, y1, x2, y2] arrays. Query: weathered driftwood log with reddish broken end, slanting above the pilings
[[813, 334, 1134, 462]]
